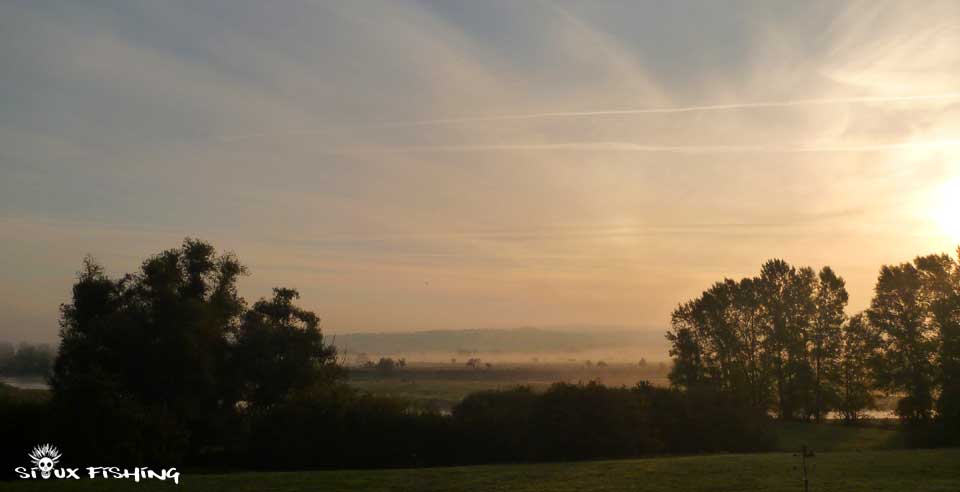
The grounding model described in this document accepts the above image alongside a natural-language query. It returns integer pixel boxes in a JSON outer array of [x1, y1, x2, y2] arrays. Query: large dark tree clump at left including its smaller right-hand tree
[[51, 238, 342, 461]]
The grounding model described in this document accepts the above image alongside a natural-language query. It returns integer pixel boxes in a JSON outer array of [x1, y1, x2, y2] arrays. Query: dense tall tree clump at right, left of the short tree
[[667, 260, 847, 419]]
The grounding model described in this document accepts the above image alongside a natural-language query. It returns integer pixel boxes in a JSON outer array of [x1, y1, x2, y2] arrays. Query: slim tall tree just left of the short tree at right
[[810, 267, 849, 422]]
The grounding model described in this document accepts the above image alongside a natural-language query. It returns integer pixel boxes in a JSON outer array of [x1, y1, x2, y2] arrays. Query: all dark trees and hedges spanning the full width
[[0, 239, 960, 469]]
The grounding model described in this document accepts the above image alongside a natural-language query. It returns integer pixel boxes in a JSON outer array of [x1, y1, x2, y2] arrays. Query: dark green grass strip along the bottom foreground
[[0, 449, 960, 492]]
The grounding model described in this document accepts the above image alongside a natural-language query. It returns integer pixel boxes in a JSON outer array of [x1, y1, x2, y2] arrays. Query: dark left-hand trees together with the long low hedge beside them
[[0, 239, 772, 469]]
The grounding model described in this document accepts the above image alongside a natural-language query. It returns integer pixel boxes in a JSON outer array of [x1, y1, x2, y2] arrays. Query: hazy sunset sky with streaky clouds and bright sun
[[0, 0, 960, 341]]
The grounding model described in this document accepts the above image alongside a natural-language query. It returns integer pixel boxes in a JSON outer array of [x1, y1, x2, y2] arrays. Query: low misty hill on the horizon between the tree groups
[[334, 328, 667, 357]]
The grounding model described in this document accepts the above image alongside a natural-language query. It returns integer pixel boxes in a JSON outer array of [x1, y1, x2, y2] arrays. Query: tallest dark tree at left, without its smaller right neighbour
[[51, 243, 245, 460]]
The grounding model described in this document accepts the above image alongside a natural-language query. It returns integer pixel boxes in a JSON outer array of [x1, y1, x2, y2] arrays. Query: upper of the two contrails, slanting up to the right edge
[[383, 92, 960, 126]]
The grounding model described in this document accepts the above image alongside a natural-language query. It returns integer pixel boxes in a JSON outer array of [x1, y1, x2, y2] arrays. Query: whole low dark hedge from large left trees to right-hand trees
[[243, 383, 775, 469]]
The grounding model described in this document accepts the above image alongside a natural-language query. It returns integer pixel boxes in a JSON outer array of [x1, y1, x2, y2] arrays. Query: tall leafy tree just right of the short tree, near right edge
[[867, 263, 937, 423]]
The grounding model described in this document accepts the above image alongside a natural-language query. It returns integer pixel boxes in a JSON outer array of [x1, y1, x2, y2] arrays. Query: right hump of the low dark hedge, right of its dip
[[453, 382, 773, 462]]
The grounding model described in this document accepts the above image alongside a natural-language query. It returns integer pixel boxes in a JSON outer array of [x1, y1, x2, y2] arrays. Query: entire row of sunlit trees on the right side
[[667, 251, 960, 438]]
